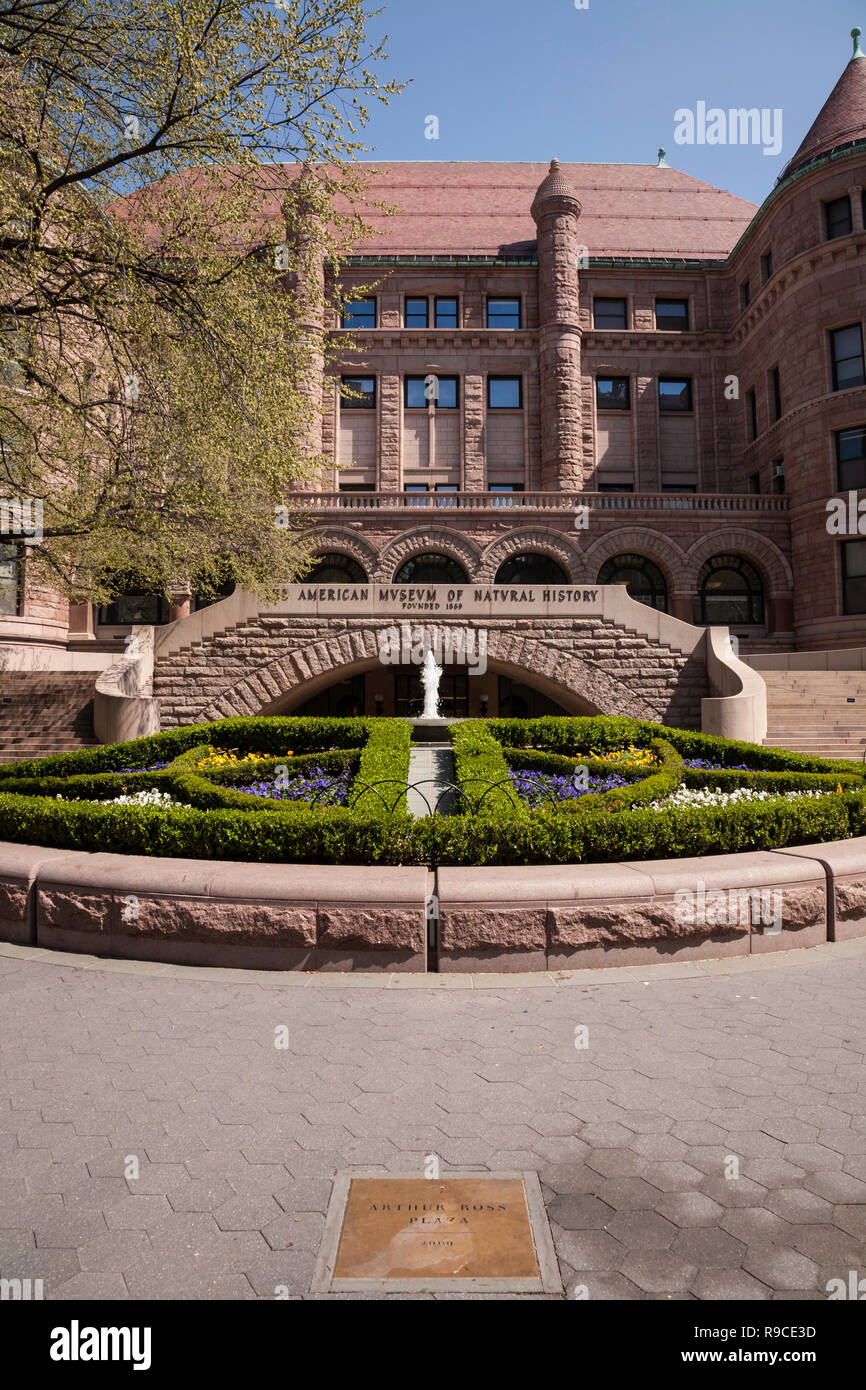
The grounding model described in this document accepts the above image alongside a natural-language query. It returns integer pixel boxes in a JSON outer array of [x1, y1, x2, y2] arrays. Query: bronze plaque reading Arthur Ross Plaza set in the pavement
[[334, 1177, 539, 1280]]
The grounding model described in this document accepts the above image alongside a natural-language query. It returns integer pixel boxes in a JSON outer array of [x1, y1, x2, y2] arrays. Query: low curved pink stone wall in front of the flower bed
[[0, 838, 866, 972]]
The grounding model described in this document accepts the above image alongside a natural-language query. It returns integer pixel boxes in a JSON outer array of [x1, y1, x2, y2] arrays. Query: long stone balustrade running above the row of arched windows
[[293, 492, 788, 514]]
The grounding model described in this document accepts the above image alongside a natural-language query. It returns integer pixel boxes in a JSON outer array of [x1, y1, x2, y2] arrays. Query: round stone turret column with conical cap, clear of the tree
[[532, 160, 584, 492]]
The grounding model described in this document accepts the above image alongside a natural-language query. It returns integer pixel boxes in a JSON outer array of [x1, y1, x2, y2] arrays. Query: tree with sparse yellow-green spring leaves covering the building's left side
[[0, 0, 400, 602]]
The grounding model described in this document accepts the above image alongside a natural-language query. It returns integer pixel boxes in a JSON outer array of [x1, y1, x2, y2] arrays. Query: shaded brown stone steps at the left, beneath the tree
[[0, 671, 97, 763]]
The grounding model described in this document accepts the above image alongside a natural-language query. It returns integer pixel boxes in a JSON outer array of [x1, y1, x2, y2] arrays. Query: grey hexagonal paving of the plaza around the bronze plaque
[[0, 954, 866, 1301]]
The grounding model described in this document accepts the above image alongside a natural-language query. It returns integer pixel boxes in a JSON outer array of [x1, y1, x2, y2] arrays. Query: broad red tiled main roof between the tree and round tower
[[265, 161, 756, 259]]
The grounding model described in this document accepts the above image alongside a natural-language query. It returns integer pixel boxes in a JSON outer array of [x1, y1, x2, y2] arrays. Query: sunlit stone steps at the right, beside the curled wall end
[[760, 670, 866, 762]]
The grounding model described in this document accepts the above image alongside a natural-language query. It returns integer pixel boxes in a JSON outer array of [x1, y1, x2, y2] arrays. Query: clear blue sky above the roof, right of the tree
[[367, 0, 866, 203]]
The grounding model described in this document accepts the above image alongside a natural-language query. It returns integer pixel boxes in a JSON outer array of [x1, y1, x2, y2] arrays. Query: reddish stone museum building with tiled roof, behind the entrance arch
[[0, 31, 866, 713]]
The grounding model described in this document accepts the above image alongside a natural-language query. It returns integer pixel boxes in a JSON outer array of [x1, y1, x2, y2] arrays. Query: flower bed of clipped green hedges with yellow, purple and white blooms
[[0, 717, 866, 865]]
